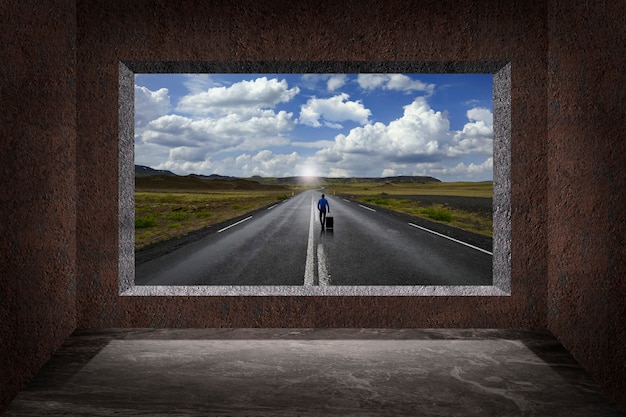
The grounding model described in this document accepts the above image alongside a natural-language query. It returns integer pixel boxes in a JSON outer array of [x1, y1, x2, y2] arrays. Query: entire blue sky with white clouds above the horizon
[[135, 74, 493, 181]]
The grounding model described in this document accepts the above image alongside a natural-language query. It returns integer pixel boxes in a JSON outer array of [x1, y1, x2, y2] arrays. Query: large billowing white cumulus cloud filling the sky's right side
[[314, 97, 493, 180]]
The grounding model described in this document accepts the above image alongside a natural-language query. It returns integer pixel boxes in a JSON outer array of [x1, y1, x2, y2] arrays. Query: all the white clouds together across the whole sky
[[135, 74, 493, 181]]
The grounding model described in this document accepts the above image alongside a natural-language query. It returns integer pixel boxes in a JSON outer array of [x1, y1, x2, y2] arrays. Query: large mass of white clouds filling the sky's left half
[[136, 74, 299, 172]]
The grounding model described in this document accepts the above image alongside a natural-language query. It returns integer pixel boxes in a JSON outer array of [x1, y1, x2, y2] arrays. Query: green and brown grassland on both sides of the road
[[135, 178, 493, 250]]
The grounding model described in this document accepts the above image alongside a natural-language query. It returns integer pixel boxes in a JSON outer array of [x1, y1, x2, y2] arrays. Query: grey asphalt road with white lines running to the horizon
[[135, 191, 492, 286]]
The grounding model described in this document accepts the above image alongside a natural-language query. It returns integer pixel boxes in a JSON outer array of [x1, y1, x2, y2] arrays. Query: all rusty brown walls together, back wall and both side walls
[[0, 0, 626, 410]]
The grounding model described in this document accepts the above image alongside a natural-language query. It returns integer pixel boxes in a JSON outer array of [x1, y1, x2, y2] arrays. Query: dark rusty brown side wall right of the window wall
[[547, 2, 626, 408]]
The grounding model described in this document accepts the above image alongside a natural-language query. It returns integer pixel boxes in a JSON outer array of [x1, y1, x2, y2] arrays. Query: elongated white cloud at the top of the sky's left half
[[176, 77, 300, 115]]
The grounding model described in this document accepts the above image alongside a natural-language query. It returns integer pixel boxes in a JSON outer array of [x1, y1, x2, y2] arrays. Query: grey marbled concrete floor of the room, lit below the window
[[3, 329, 625, 417]]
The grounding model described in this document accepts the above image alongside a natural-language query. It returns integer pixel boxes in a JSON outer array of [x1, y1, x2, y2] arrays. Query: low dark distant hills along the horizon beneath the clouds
[[135, 165, 441, 190]]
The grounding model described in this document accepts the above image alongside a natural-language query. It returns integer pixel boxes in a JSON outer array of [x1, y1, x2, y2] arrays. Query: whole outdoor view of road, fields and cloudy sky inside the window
[[134, 73, 493, 286]]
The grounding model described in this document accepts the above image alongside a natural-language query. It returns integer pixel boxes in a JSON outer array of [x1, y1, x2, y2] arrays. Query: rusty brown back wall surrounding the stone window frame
[[77, 1, 548, 328]]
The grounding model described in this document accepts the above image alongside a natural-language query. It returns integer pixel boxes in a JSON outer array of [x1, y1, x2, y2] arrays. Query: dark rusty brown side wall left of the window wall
[[0, 0, 77, 411]]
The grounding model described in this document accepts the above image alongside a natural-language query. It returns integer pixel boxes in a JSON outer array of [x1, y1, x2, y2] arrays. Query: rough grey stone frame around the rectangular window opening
[[118, 61, 511, 296]]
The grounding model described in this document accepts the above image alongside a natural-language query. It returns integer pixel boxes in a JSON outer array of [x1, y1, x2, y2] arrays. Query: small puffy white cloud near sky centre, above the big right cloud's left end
[[299, 93, 372, 128]]
